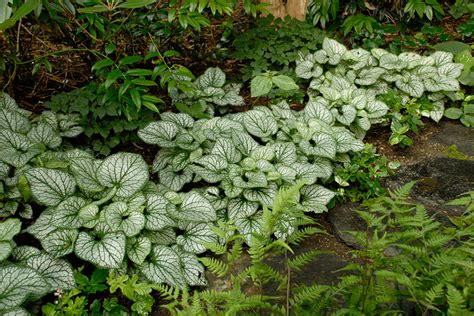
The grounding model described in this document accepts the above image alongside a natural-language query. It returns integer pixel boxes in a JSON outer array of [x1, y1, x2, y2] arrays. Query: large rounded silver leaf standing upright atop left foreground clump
[[97, 153, 148, 197]]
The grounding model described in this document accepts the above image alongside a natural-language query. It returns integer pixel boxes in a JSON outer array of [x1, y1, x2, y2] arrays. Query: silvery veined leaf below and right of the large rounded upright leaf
[[144, 194, 175, 231]]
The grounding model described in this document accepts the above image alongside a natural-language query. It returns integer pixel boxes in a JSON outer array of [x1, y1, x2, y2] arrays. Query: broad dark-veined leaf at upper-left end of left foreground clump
[[26, 168, 76, 206]]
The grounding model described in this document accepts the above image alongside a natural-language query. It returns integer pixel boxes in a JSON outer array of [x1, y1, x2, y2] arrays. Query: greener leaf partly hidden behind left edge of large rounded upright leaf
[[71, 158, 104, 192]]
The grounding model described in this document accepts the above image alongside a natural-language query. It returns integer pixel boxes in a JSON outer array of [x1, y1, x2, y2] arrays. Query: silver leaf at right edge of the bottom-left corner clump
[[25, 253, 76, 290]]
